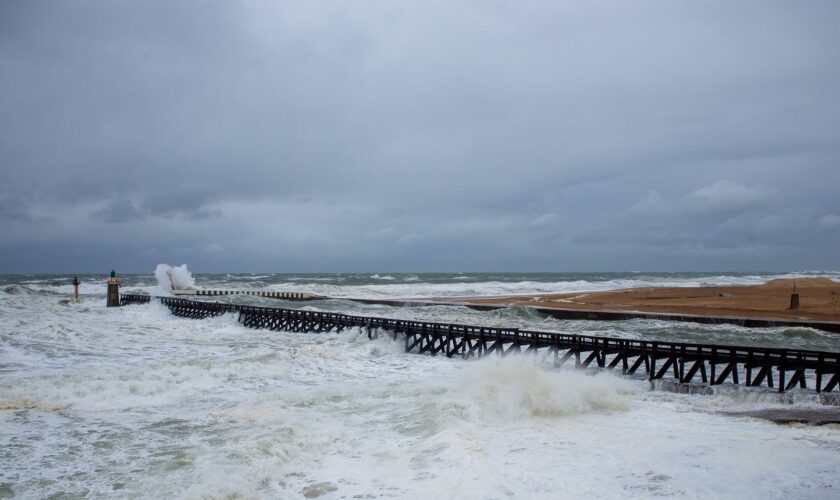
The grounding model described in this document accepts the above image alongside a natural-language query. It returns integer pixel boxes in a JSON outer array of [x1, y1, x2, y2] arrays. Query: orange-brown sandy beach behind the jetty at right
[[435, 278, 840, 321]]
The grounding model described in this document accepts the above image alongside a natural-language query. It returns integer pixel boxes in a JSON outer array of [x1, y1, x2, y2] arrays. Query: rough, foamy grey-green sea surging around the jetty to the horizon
[[0, 271, 840, 499]]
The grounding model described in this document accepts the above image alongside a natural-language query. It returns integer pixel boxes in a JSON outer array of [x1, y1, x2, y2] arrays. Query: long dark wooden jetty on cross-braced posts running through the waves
[[120, 294, 840, 393]]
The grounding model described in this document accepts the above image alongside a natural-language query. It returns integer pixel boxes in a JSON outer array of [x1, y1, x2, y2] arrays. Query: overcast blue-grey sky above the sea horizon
[[0, 0, 840, 273]]
